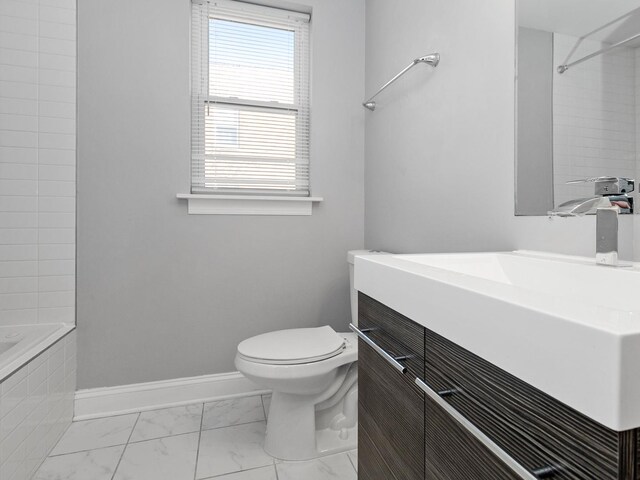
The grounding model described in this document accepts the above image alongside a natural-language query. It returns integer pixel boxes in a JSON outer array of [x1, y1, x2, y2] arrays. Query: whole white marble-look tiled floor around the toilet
[[33, 395, 358, 480]]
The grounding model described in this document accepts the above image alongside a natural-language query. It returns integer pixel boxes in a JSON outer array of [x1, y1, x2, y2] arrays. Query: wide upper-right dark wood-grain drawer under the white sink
[[425, 330, 632, 480]]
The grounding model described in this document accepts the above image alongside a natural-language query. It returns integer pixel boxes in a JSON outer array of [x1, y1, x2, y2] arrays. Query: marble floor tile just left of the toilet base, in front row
[[196, 422, 273, 479]]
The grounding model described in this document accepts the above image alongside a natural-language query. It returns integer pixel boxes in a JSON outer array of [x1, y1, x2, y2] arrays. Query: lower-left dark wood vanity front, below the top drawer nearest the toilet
[[358, 334, 424, 480]]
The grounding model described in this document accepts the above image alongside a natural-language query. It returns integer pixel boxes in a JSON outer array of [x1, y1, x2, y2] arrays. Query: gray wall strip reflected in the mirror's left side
[[516, 27, 554, 215]]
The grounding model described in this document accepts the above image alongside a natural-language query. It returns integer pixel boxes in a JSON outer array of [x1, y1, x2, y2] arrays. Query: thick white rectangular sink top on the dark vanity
[[355, 251, 640, 431]]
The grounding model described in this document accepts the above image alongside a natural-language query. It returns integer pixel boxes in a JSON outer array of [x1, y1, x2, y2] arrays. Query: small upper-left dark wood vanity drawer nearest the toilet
[[358, 293, 425, 383]]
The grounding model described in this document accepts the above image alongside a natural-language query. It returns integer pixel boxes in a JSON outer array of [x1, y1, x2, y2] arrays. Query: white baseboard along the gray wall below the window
[[74, 372, 268, 420]]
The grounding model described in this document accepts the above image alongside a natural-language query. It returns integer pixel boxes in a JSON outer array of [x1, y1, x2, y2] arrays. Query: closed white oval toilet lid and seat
[[238, 326, 345, 365]]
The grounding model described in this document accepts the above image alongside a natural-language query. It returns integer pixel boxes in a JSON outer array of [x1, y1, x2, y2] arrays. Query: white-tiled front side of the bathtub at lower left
[[0, 331, 76, 480]]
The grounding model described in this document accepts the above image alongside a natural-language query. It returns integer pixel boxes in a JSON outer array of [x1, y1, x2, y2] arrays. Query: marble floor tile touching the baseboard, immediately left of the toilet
[[202, 395, 265, 430]]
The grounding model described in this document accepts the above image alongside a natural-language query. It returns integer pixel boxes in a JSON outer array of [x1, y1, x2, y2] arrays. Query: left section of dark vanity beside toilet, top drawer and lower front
[[358, 295, 425, 480]]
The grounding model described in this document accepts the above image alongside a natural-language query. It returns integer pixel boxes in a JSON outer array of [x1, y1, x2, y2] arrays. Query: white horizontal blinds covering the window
[[191, 0, 309, 196]]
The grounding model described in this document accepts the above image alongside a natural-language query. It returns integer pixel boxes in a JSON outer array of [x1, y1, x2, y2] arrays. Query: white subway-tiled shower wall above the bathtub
[[0, 0, 76, 325]]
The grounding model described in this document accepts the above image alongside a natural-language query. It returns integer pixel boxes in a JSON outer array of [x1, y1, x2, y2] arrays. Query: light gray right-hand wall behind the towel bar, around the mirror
[[365, 0, 633, 258]]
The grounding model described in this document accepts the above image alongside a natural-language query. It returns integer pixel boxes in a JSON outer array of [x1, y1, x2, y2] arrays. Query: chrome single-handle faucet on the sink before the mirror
[[549, 177, 635, 266]]
